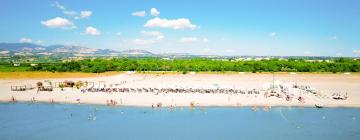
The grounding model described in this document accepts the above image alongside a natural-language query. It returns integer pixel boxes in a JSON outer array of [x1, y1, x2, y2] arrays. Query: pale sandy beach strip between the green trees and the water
[[0, 72, 360, 107]]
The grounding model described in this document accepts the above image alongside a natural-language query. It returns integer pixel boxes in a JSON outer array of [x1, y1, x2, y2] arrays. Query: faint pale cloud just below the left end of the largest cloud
[[132, 31, 165, 45]]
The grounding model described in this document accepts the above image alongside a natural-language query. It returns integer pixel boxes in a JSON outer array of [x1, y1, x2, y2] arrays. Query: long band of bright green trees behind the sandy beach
[[23, 58, 360, 73]]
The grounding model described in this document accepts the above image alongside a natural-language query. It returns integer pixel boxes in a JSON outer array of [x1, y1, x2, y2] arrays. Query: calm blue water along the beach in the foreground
[[0, 103, 360, 140]]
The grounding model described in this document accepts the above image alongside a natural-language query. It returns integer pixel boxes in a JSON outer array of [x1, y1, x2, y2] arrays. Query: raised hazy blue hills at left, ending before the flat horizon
[[0, 43, 154, 57]]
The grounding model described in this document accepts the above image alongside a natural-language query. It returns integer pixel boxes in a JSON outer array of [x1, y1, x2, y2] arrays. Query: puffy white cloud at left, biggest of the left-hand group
[[41, 17, 75, 29]]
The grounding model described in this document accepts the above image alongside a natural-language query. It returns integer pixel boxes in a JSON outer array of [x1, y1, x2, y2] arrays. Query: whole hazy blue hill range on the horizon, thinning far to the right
[[0, 43, 348, 60]]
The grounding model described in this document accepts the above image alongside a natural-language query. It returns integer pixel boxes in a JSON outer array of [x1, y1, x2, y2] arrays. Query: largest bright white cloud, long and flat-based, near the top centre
[[144, 17, 198, 30]]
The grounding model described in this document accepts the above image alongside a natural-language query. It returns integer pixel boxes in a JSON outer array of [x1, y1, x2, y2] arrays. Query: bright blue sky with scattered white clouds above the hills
[[0, 0, 360, 57]]
